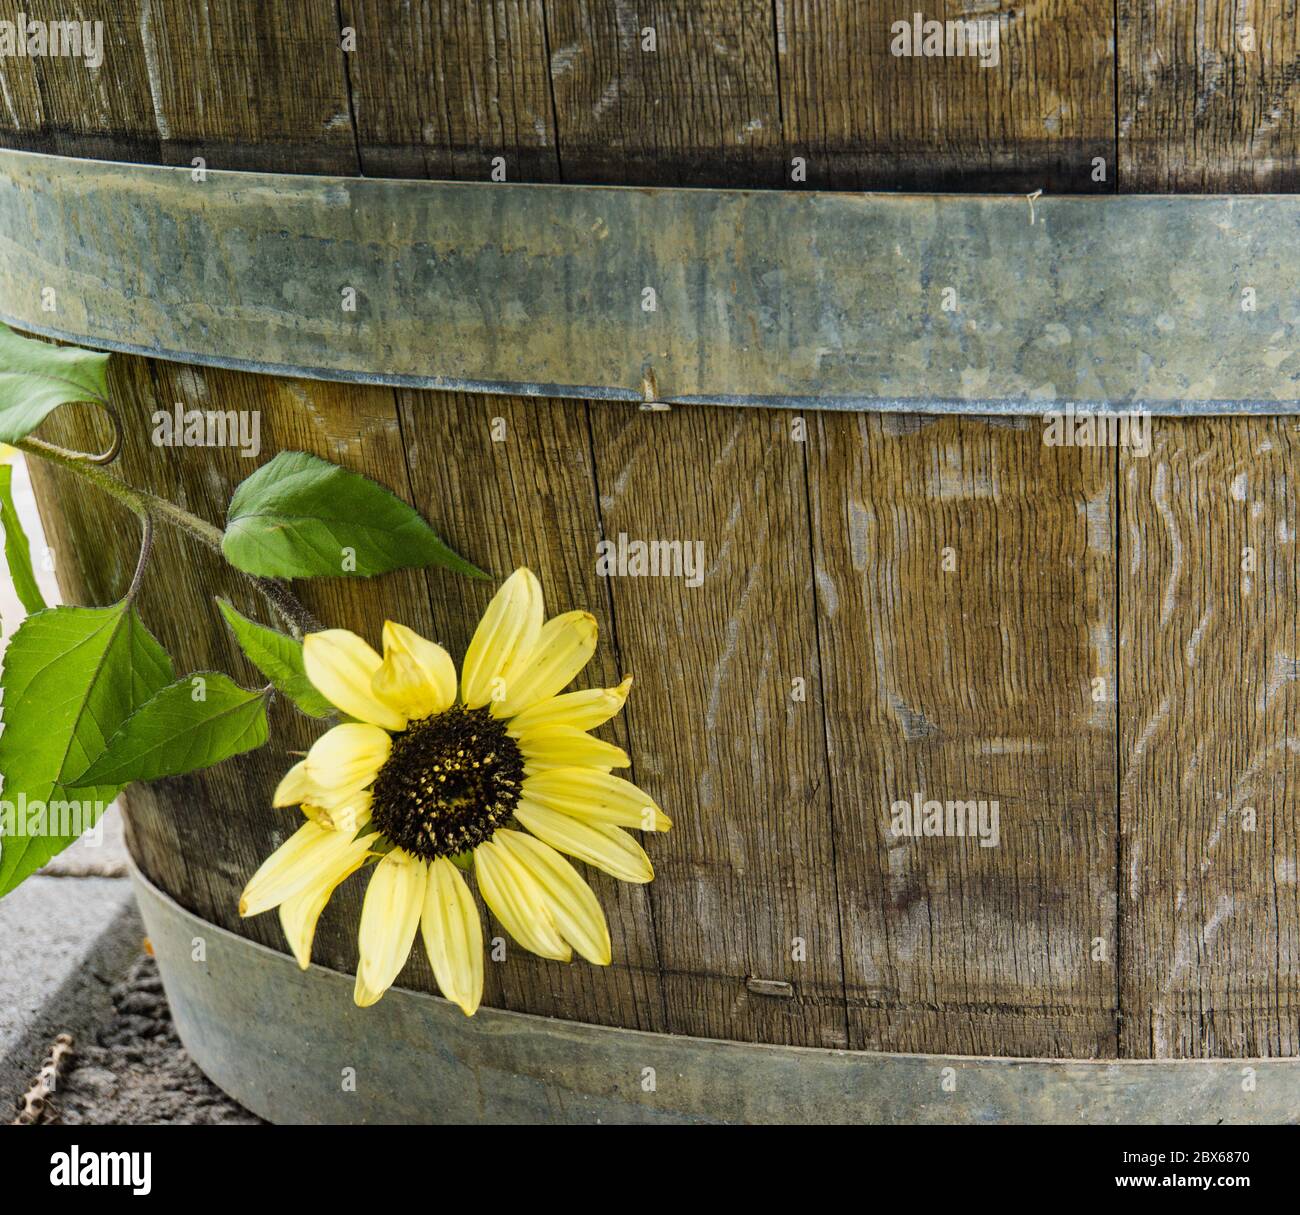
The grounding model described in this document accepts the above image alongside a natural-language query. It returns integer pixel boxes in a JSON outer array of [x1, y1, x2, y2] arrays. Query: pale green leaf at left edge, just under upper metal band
[[0, 325, 108, 443]]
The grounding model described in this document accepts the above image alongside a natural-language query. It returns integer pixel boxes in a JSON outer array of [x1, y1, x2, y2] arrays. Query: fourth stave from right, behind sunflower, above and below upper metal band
[[335, 3, 666, 1030]]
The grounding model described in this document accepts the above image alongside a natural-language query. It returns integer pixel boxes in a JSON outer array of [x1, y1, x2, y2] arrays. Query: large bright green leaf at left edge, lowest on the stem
[[0, 600, 173, 895]]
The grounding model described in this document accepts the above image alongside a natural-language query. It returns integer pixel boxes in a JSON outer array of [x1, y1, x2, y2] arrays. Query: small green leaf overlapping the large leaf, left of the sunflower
[[78, 671, 268, 785]]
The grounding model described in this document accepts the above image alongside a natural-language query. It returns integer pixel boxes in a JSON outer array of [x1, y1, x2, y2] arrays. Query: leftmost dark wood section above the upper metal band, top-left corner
[[0, 0, 356, 173]]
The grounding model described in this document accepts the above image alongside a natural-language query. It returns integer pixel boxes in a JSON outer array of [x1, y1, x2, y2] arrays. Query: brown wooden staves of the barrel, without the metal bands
[[0, 0, 1300, 1107]]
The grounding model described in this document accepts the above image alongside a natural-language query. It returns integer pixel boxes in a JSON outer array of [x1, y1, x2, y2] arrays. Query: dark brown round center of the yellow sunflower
[[371, 704, 524, 860]]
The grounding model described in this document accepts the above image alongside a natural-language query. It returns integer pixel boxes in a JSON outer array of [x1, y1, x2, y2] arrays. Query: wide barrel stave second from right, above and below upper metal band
[[776, 0, 1117, 1056]]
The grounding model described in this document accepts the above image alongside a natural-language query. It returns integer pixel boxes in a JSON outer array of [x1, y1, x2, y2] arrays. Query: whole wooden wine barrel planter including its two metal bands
[[0, 0, 1300, 1121]]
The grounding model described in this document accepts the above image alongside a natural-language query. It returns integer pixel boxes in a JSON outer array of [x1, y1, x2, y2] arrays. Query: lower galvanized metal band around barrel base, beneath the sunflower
[[134, 872, 1300, 1124]]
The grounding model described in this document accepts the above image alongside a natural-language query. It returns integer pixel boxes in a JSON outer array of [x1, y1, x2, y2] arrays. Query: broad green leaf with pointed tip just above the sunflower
[[221, 451, 486, 578]]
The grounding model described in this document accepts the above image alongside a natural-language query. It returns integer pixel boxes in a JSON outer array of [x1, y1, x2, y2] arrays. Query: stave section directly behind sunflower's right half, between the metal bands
[[398, 391, 671, 1029]]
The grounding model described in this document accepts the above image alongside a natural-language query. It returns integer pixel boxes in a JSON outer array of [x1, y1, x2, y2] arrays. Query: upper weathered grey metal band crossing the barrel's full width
[[0, 151, 1300, 413]]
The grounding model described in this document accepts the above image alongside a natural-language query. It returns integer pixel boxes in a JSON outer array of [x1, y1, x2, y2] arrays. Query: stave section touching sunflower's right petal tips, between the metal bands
[[592, 405, 845, 1046]]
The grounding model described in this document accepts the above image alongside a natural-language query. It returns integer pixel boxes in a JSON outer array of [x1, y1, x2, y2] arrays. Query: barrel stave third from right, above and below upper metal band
[[535, 0, 845, 1046]]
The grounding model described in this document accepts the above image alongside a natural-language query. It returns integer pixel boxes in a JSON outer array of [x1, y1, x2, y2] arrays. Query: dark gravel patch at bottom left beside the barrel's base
[[12, 954, 260, 1125]]
